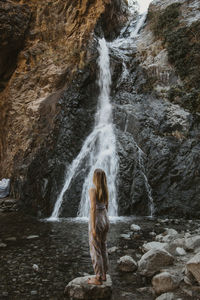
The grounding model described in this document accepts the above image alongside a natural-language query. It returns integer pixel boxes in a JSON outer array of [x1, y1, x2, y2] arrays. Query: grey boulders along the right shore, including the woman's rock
[[66, 218, 200, 300]]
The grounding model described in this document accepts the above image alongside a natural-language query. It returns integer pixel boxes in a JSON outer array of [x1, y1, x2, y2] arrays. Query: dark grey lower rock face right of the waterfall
[[112, 51, 200, 217]]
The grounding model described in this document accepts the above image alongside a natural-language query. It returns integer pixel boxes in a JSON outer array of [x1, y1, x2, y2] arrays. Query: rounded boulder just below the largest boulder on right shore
[[152, 272, 181, 294]]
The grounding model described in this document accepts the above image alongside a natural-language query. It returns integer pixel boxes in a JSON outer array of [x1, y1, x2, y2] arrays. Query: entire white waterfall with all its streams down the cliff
[[48, 0, 153, 220]]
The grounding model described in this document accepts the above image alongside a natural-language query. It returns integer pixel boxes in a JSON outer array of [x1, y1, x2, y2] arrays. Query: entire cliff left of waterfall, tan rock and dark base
[[0, 0, 127, 214]]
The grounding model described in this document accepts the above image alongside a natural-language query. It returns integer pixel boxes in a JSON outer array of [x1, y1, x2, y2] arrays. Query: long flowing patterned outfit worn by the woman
[[89, 196, 110, 278]]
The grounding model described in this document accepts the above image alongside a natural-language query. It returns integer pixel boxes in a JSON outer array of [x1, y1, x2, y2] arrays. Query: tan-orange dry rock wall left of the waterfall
[[0, 0, 124, 180]]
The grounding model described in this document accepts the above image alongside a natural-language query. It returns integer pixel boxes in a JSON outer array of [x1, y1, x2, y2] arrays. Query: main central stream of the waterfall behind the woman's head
[[79, 39, 118, 217]]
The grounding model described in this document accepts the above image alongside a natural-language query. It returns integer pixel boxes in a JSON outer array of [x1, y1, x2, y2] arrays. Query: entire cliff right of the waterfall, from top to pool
[[113, 0, 200, 216]]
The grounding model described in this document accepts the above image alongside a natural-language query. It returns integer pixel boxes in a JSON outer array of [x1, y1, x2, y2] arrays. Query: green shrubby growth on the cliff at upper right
[[148, 3, 200, 112]]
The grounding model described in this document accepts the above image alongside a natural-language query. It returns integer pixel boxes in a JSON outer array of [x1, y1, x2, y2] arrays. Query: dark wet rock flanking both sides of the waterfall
[[5, 1, 200, 217]]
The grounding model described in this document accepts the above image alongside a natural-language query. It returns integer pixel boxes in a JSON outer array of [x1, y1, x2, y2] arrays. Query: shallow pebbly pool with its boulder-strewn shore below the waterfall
[[0, 211, 200, 300]]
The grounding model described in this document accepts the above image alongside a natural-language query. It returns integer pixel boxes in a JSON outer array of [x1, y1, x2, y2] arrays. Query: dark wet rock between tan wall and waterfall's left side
[[13, 58, 98, 217]]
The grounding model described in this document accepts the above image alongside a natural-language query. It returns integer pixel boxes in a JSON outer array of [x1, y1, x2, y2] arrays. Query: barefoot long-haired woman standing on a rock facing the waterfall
[[88, 169, 109, 284]]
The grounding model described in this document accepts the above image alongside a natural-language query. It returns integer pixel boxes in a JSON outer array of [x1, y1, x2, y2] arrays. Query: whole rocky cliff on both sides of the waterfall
[[0, 0, 200, 216]]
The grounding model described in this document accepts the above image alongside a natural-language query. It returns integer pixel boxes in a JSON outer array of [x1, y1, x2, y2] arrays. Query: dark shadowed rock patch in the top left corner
[[0, 1, 31, 91]]
